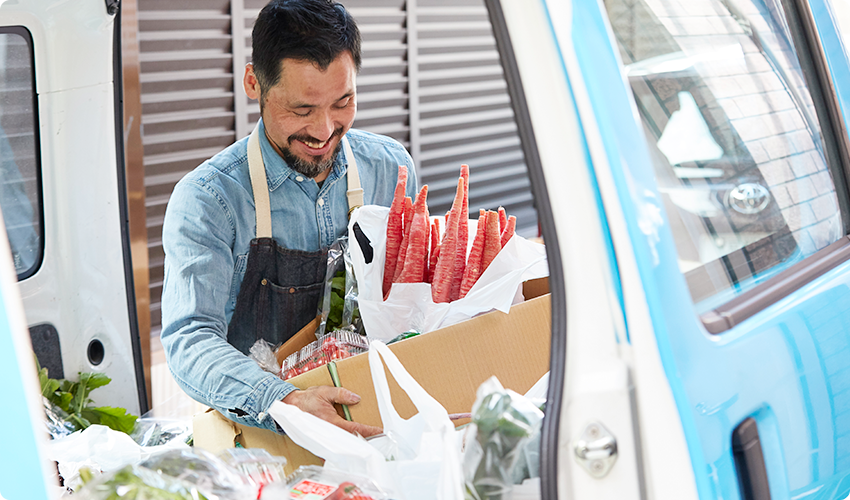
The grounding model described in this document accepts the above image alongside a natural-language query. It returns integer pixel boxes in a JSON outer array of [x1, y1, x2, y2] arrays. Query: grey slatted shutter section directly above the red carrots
[[412, 0, 537, 236]]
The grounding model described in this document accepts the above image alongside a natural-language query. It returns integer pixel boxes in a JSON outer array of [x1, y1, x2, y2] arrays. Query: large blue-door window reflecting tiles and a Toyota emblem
[[605, 0, 843, 314]]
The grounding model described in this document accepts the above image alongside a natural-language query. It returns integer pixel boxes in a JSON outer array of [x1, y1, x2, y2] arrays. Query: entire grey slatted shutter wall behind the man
[[138, 0, 537, 336]]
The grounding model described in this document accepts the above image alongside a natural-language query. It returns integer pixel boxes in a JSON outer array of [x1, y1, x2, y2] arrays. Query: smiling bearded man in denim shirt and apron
[[162, 0, 416, 435]]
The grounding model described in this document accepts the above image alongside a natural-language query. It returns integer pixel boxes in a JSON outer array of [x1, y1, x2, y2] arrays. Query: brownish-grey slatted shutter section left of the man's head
[[138, 0, 235, 336]]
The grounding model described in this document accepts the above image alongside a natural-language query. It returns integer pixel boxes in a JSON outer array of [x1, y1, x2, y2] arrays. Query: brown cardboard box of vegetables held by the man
[[194, 280, 551, 473]]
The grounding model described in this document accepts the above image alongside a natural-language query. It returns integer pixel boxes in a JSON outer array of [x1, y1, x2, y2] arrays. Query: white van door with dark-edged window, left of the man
[[0, 0, 148, 415]]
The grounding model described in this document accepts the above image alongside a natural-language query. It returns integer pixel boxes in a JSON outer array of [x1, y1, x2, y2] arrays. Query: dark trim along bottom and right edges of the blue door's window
[[699, 0, 850, 335]]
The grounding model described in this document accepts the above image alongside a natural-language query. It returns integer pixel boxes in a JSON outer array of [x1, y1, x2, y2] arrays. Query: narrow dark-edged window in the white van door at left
[[0, 27, 43, 280]]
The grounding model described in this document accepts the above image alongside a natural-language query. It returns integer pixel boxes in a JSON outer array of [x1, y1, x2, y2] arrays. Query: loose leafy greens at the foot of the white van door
[[36, 360, 138, 434]]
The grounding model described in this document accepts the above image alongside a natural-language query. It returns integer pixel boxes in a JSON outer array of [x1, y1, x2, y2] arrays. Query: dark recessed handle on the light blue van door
[[732, 417, 770, 500]]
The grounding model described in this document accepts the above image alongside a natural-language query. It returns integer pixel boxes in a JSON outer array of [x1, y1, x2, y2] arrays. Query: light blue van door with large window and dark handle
[[552, 0, 850, 499]]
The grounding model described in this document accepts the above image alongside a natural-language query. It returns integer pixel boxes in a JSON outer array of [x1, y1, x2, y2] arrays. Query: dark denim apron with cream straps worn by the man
[[227, 126, 363, 354]]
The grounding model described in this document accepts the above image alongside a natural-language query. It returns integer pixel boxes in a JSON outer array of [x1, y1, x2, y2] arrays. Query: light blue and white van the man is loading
[[0, 0, 850, 500]]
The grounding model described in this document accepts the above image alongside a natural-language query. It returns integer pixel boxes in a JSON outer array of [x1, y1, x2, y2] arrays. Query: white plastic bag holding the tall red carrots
[[348, 205, 549, 342]]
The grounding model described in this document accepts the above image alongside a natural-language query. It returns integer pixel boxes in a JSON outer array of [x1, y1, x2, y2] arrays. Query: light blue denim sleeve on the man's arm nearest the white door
[[161, 178, 295, 430]]
